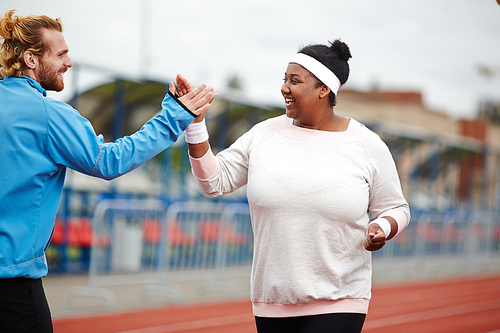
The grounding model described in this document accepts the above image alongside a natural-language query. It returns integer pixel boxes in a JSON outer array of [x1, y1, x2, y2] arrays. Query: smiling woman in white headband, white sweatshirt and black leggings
[[182, 40, 410, 333]]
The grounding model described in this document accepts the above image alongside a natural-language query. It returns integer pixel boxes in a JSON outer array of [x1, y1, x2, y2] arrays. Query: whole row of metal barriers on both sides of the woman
[[66, 200, 500, 307]]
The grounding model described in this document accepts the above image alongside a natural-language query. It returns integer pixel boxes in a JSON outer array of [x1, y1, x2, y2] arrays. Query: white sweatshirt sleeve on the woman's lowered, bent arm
[[365, 134, 410, 234]]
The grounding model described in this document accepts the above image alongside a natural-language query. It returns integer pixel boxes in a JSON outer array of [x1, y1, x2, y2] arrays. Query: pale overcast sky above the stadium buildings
[[0, 0, 500, 118]]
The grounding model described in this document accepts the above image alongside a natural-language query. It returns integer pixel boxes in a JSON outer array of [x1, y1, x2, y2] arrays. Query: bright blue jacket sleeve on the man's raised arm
[[46, 92, 195, 180]]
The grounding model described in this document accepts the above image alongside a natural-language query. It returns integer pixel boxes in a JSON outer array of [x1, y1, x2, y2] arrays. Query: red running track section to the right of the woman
[[363, 276, 500, 333]]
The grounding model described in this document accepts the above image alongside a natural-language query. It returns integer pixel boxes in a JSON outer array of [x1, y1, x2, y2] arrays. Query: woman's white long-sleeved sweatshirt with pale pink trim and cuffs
[[191, 116, 410, 317]]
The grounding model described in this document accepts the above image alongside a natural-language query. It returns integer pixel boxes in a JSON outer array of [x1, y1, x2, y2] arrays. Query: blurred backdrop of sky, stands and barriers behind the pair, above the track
[[0, 0, 500, 317]]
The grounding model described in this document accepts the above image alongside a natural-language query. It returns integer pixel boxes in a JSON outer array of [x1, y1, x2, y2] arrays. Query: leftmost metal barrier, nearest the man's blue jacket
[[66, 199, 171, 307]]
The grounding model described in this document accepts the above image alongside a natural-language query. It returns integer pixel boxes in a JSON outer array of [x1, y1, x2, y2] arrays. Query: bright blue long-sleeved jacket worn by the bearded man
[[0, 76, 195, 278]]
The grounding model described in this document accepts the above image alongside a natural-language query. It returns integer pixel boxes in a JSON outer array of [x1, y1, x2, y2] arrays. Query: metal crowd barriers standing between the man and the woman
[[66, 200, 253, 307]]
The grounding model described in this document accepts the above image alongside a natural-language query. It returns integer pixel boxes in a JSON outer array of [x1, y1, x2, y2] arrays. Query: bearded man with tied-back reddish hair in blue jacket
[[0, 10, 216, 332]]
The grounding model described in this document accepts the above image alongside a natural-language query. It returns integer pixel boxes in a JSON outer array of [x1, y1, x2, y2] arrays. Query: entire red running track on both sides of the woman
[[54, 275, 500, 333]]
